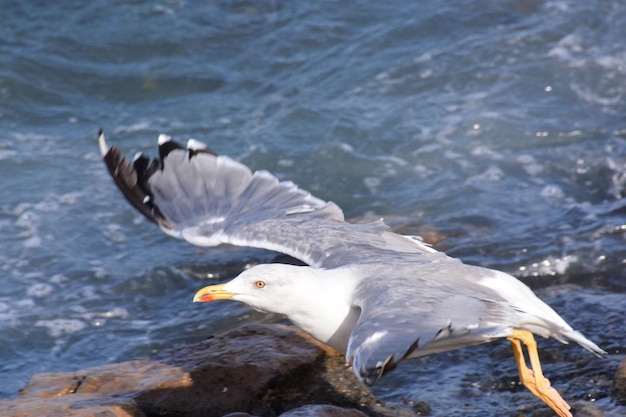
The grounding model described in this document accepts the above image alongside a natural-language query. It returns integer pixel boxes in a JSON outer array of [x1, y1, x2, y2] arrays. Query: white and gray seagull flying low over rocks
[[98, 131, 606, 417]]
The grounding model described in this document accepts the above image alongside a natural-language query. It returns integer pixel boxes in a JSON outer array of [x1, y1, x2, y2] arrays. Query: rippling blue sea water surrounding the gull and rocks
[[0, 0, 626, 416]]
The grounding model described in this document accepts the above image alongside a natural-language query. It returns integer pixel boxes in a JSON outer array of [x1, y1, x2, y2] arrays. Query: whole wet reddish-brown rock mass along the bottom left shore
[[0, 324, 400, 417]]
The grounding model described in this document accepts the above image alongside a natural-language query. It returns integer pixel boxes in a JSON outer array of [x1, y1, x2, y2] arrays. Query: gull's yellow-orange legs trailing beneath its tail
[[508, 329, 572, 417]]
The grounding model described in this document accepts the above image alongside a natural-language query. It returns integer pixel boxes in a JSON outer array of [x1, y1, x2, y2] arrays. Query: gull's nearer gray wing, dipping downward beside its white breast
[[346, 262, 519, 385]]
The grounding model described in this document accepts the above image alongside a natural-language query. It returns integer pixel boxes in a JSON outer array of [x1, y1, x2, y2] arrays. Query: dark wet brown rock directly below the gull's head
[[135, 325, 332, 416]]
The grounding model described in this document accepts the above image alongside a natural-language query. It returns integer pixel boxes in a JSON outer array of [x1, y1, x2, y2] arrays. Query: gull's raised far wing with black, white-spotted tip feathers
[[99, 132, 434, 267]]
